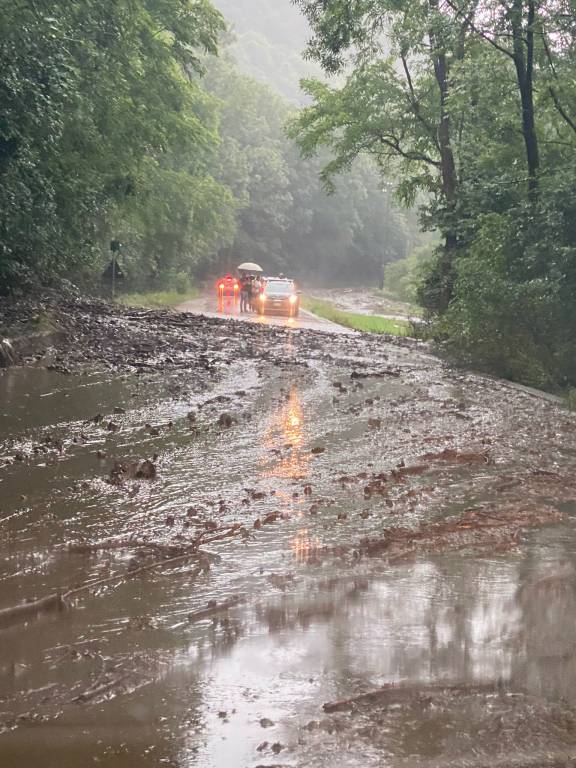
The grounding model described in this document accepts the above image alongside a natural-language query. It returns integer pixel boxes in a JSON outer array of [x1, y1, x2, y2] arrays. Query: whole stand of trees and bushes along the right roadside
[[292, 0, 576, 387]]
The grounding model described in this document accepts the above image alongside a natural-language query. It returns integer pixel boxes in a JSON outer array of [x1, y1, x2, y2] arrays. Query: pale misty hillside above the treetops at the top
[[215, 0, 319, 102]]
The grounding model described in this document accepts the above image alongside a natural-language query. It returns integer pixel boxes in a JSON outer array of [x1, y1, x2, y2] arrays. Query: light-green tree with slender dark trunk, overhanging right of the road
[[292, 0, 470, 308]]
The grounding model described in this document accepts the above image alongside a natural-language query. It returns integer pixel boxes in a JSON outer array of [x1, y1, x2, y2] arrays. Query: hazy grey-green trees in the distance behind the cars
[[205, 51, 411, 284]]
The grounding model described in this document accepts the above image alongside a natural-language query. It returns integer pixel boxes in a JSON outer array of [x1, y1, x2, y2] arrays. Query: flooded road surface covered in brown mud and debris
[[0, 299, 576, 768]]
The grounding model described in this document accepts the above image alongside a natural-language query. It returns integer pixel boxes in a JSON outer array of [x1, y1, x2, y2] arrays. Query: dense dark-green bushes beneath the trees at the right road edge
[[440, 189, 576, 389]]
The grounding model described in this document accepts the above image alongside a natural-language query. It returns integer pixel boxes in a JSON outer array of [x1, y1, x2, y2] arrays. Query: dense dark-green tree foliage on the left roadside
[[0, 0, 229, 289]]
